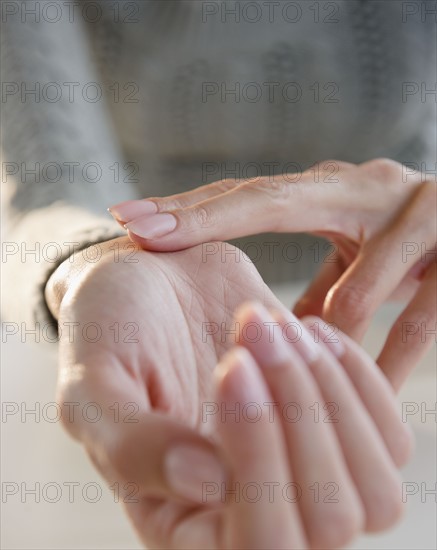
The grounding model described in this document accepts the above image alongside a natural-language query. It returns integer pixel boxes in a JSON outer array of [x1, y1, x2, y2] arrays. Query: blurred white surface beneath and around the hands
[[1, 286, 437, 550]]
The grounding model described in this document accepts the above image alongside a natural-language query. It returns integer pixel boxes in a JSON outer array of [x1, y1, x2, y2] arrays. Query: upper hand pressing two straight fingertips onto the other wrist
[[110, 159, 437, 388]]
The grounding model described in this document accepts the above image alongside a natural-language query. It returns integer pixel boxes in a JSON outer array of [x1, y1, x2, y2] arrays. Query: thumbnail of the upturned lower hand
[[164, 445, 226, 502]]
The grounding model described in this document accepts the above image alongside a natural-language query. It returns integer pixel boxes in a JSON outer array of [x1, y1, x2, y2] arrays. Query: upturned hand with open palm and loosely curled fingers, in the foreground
[[46, 237, 411, 549]]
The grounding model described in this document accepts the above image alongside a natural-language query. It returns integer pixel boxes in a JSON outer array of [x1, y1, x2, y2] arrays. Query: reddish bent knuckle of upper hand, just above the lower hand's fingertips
[[327, 285, 373, 328]]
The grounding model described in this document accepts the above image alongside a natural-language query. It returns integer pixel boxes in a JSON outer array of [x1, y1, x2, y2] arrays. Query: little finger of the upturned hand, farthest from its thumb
[[302, 317, 413, 467]]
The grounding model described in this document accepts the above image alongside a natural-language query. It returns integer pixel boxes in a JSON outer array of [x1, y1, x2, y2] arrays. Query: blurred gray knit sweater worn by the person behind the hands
[[1, 0, 437, 328]]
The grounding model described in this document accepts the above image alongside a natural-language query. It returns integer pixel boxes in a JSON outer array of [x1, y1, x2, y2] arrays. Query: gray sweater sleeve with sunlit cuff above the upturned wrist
[[1, 1, 136, 332]]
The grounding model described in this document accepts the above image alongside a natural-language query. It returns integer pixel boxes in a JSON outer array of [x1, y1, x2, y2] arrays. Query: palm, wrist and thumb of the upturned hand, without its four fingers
[[46, 237, 286, 548]]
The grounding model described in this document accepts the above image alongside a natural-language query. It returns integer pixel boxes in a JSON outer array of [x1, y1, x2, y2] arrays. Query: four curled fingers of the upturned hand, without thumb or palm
[[213, 304, 411, 549]]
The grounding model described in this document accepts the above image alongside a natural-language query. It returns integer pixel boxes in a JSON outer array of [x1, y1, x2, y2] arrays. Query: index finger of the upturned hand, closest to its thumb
[[216, 347, 307, 550]]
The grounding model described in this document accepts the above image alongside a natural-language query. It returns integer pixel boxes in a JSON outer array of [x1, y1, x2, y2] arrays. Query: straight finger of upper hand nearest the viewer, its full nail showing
[[121, 177, 347, 251]]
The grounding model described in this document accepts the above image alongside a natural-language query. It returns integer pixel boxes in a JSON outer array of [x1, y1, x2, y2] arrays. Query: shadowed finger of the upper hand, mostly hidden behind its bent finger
[[293, 254, 344, 317]]
